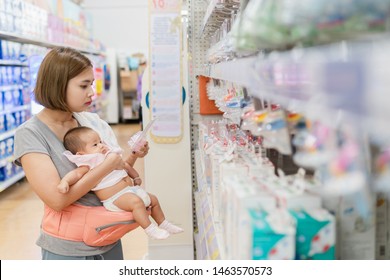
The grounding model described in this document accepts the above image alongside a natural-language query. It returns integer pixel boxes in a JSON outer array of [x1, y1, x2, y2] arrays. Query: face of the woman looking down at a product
[[66, 68, 95, 112]]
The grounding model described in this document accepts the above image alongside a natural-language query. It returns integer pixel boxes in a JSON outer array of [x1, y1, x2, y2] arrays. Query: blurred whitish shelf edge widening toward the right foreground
[[201, 36, 390, 137]]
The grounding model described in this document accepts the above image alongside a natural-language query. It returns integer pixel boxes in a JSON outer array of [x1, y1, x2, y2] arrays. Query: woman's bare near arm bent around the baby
[[20, 153, 124, 211]]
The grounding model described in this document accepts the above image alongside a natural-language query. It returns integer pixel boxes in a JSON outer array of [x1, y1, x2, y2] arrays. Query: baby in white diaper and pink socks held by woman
[[58, 127, 183, 239]]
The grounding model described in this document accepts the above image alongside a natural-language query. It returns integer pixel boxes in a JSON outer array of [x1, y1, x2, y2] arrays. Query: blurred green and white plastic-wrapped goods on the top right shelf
[[232, 0, 390, 51]]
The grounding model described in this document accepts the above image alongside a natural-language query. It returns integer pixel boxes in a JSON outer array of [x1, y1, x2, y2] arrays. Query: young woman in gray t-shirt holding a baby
[[14, 47, 149, 260]]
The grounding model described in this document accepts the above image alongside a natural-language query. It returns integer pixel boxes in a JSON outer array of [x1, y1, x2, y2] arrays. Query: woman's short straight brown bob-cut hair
[[34, 47, 93, 112]]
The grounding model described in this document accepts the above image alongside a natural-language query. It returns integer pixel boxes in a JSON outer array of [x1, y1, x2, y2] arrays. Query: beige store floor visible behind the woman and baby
[[0, 124, 148, 260]]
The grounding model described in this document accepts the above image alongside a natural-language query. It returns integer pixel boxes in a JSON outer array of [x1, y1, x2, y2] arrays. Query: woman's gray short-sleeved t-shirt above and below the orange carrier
[[14, 113, 117, 256]]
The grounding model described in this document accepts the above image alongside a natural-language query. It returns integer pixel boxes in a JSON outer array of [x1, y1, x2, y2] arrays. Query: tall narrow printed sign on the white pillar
[[149, 0, 183, 144]]
